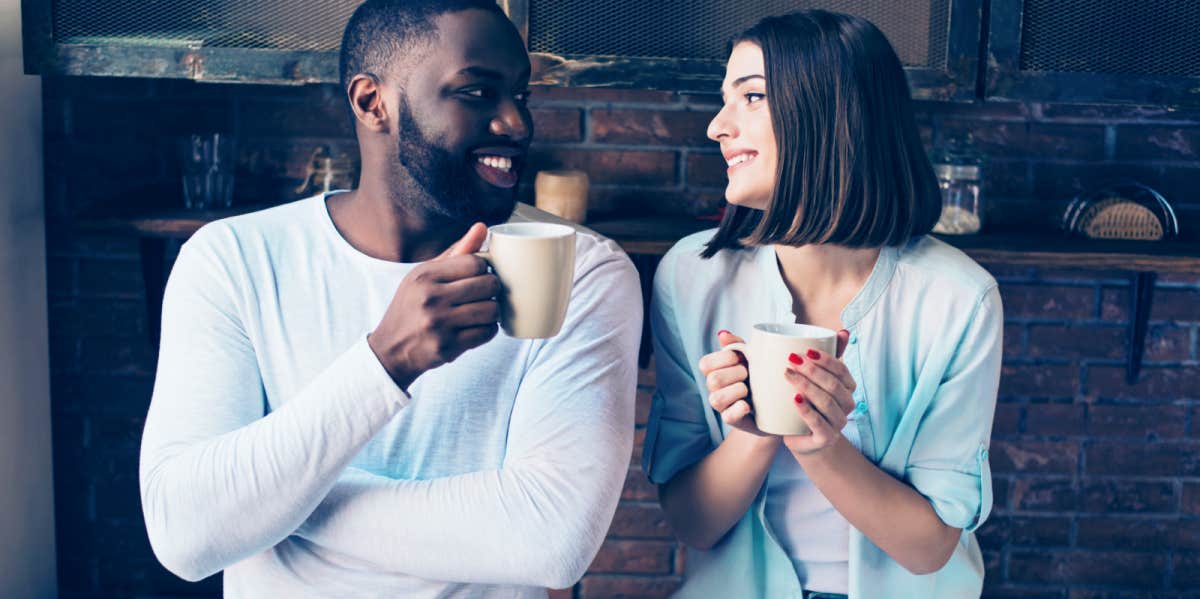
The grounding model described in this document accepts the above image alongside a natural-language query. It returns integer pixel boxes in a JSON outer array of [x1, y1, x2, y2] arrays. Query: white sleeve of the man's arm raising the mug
[[139, 226, 407, 580]]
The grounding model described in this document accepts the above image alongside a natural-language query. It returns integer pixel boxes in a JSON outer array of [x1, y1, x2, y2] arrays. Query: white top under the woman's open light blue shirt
[[766, 414, 860, 593]]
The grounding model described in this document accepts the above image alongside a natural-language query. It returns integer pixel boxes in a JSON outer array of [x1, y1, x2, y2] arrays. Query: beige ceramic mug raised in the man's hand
[[475, 222, 575, 339]]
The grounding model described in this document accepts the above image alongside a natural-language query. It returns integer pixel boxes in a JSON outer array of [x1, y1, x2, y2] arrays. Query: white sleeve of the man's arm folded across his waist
[[296, 244, 642, 588]]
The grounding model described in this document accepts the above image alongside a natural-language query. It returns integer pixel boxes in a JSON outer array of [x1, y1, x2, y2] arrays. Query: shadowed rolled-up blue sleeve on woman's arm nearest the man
[[642, 254, 713, 485]]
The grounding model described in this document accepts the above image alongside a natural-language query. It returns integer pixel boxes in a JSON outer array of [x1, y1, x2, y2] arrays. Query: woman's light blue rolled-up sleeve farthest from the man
[[905, 286, 1004, 532]]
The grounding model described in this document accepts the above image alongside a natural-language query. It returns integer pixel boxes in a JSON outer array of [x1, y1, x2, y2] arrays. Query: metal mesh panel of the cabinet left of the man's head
[[54, 0, 362, 50]]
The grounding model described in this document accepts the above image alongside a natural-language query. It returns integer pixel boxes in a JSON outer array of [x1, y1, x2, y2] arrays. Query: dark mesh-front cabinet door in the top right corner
[[986, 0, 1200, 106]]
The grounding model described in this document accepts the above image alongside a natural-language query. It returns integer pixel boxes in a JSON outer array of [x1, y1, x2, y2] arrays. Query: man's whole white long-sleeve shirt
[[140, 196, 642, 597]]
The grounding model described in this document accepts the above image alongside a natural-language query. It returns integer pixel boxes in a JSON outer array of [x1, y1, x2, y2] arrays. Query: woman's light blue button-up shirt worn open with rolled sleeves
[[642, 230, 1003, 599]]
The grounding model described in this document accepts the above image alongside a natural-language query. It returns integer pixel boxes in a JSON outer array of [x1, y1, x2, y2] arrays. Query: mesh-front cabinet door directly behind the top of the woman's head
[[516, 0, 982, 100]]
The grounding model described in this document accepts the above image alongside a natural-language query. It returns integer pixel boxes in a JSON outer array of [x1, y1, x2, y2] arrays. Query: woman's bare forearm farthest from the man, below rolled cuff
[[793, 437, 961, 574]]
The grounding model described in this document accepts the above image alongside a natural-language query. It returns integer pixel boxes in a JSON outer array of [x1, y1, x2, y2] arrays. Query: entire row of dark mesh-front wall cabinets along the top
[[22, 0, 1200, 106]]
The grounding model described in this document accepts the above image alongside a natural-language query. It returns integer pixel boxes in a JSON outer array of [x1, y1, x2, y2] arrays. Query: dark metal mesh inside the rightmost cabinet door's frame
[[1020, 0, 1200, 77]]
